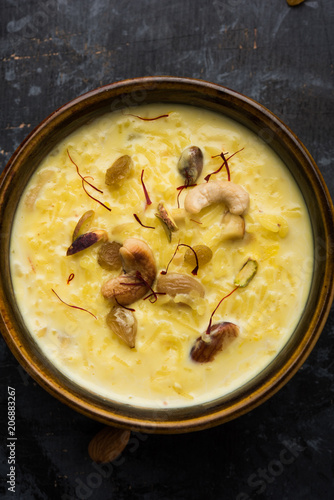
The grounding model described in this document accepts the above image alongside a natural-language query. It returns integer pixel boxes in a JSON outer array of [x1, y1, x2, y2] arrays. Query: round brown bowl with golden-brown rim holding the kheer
[[0, 77, 334, 433]]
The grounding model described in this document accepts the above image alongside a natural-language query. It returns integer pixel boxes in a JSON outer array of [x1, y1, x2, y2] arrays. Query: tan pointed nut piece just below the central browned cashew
[[106, 306, 137, 348]]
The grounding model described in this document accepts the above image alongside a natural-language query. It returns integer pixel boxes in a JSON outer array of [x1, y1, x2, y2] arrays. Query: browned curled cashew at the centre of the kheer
[[101, 238, 157, 306]]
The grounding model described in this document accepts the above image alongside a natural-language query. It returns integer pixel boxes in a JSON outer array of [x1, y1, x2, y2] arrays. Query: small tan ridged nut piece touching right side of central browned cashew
[[157, 273, 205, 297]]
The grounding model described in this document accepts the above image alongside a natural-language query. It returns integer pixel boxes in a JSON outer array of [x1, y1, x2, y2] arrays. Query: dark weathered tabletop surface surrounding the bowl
[[0, 0, 334, 500]]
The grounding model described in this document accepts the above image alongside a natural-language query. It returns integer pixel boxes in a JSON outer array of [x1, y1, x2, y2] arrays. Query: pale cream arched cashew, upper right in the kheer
[[184, 181, 249, 215]]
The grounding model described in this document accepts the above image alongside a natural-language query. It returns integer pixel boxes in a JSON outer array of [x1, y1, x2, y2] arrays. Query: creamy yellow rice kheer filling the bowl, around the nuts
[[11, 104, 313, 407]]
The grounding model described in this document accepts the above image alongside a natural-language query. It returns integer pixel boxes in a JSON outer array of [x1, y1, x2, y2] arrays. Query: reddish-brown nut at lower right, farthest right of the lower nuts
[[190, 321, 239, 363]]
